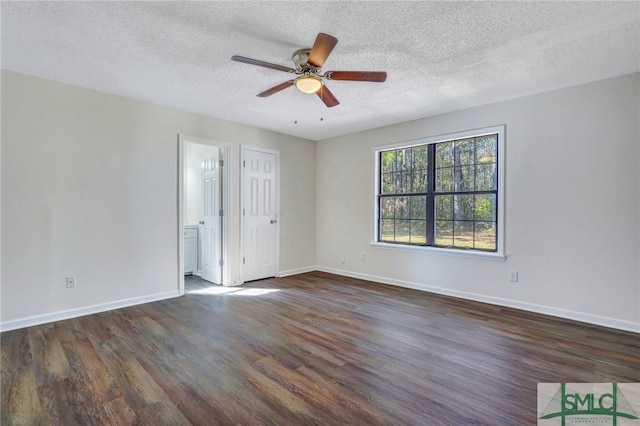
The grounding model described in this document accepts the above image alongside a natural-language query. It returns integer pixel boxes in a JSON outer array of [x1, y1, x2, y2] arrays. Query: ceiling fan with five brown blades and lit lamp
[[231, 33, 387, 108]]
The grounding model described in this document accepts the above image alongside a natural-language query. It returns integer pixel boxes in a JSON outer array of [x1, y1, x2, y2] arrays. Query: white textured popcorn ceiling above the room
[[1, 1, 640, 140]]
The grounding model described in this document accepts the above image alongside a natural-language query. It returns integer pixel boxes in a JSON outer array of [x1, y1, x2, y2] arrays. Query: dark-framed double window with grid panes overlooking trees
[[376, 127, 503, 253]]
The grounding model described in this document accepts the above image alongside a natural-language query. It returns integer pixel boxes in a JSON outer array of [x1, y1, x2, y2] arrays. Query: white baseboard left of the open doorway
[[0, 290, 180, 332]]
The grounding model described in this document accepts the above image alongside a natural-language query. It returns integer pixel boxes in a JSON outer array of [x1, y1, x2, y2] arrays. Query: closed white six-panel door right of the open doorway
[[242, 149, 278, 281]]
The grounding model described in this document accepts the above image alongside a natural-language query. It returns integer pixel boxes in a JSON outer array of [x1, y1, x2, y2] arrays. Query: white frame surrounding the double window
[[370, 125, 506, 261]]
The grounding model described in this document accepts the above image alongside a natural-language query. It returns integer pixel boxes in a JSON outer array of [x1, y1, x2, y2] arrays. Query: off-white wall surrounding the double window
[[316, 74, 640, 331]]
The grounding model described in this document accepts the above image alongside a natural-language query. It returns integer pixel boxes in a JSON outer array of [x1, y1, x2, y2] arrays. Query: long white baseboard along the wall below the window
[[316, 266, 640, 333]]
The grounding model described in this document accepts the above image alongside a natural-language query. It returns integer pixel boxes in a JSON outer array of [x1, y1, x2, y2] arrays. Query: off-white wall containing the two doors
[[1, 70, 316, 329]]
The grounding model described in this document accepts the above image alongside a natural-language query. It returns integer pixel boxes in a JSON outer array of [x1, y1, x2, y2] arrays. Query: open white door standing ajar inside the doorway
[[200, 150, 222, 284]]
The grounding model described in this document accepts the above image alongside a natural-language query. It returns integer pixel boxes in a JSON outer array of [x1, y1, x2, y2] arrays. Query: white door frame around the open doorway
[[176, 134, 231, 296]]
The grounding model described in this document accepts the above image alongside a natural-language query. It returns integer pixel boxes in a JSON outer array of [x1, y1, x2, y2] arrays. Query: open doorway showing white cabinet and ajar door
[[178, 136, 229, 294]]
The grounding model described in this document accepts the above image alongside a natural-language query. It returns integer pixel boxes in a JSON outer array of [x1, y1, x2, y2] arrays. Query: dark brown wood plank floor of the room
[[1, 272, 640, 426]]
